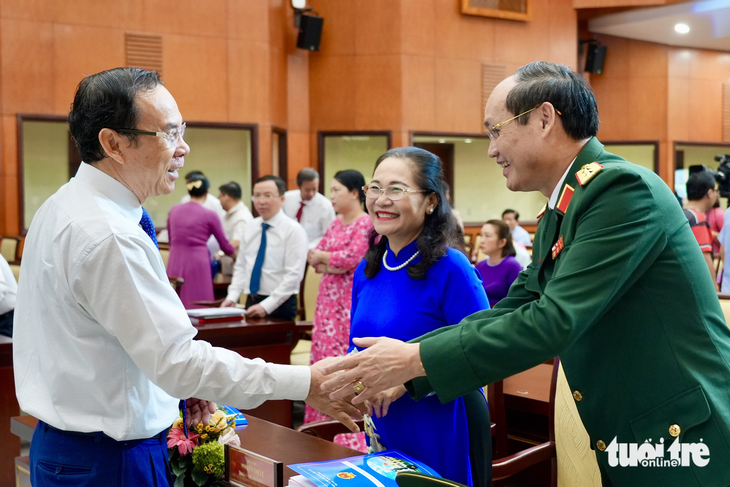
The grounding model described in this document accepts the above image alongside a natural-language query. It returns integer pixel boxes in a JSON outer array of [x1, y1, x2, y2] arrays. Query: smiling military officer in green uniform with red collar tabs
[[323, 62, 730, 487]]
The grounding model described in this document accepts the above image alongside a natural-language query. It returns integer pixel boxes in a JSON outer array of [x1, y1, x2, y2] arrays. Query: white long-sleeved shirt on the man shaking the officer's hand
[[13, 163, 310, 440]]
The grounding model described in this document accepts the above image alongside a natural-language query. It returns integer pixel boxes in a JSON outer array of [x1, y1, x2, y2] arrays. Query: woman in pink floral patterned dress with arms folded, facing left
[[304, 170, 373, 451]]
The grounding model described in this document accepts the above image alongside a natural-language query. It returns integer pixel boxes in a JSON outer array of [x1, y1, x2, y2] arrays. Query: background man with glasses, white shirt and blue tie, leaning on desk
[[221, 176, 307, 320]]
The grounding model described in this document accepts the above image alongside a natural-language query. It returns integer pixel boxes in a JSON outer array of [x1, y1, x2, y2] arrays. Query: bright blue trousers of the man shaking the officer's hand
[[30, 421, 172, 487]]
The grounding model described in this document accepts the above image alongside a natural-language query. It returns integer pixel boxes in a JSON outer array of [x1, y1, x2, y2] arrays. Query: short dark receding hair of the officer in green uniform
[[505, 61, 598, 140]]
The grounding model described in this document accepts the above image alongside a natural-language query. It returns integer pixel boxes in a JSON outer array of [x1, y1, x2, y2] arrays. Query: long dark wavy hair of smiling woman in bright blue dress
[[365, 147, 458, 279]]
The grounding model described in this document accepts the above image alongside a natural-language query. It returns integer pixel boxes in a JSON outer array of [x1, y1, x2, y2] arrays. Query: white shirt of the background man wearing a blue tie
[[227, 210, 308, 314]]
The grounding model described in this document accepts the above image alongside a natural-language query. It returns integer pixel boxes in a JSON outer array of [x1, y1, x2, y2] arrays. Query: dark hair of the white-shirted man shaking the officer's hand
[[68, 68, 162, 163]]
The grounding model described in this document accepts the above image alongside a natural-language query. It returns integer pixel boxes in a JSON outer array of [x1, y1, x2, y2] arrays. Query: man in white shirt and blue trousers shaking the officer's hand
[[13, 68, 360, 486]]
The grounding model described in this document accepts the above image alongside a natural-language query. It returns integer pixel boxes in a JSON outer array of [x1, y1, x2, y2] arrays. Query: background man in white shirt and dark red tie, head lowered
[[284, 167, 335, 249]]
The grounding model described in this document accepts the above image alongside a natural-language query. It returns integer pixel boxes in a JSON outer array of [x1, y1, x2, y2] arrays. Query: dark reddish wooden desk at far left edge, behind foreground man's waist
[[0, 335, 20, 487]]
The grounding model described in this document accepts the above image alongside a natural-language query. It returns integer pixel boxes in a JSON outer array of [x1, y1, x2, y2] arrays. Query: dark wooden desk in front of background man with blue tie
[[191, 318, 305, 427]]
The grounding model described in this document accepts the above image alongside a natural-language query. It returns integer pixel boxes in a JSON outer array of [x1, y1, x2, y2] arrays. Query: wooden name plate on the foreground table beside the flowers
[[226, 445, 284, 487]]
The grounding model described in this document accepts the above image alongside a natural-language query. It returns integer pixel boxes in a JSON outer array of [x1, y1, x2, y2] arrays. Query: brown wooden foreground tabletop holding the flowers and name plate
[[10, 416, 362, 485]]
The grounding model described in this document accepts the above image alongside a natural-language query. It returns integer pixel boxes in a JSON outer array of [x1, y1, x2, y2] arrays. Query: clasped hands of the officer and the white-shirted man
[[305, 338, 426, 433]]
